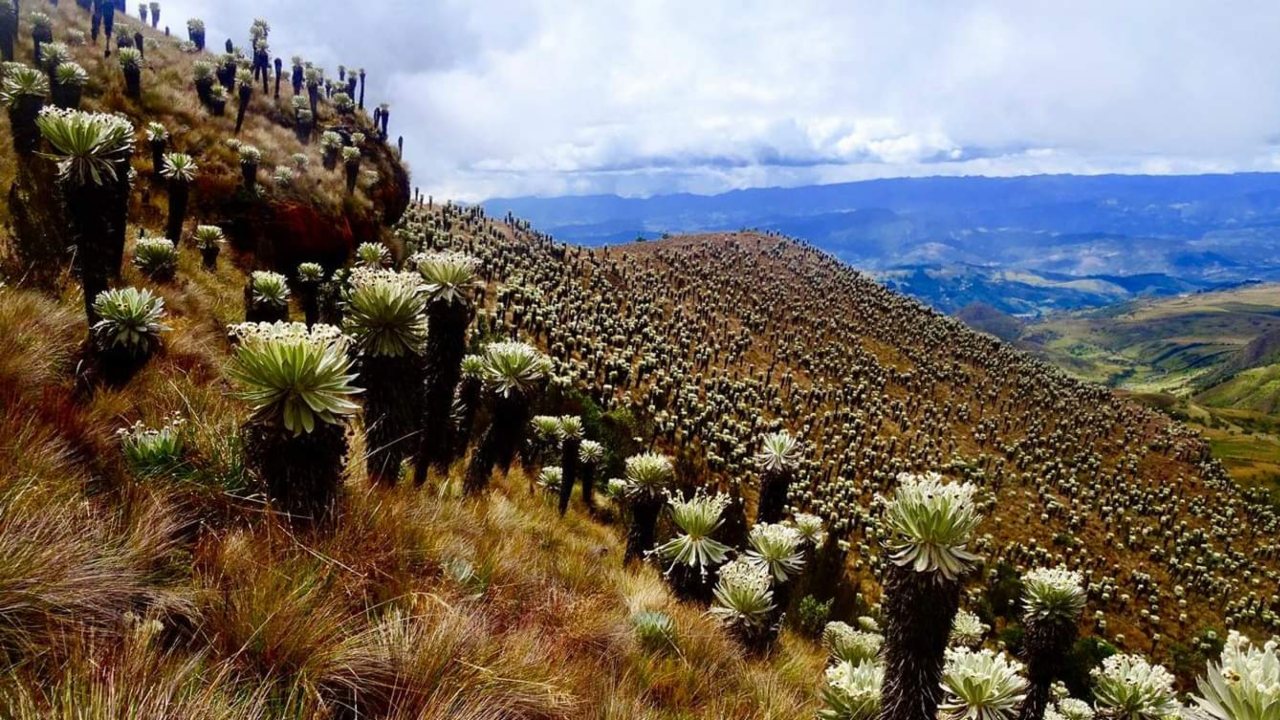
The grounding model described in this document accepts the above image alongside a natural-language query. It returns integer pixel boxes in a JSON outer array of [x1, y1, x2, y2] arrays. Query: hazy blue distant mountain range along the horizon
[[484, 173, 1280, 315]]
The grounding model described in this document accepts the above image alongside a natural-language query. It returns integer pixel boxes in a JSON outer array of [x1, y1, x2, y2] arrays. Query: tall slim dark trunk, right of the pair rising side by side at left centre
[[413, 300, 470, 484]]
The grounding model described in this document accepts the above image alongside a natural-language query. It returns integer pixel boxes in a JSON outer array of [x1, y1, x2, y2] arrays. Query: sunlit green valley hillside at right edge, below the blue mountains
[[993, 284, 1280, 488]]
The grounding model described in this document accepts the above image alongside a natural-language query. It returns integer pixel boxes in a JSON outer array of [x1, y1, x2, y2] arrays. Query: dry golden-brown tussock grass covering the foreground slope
[[0, 260, 824, 720]]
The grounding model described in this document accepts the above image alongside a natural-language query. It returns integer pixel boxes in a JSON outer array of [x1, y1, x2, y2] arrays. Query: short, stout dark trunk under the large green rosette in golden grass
[[244, 421, 347, 524]]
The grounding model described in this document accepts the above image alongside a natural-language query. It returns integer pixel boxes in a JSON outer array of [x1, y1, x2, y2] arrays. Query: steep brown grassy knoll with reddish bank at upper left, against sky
[[0, 3, 410, 277]]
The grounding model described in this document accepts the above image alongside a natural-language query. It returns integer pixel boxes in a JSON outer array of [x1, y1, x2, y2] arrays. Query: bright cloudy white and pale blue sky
[[154, 0, 1280, 201]]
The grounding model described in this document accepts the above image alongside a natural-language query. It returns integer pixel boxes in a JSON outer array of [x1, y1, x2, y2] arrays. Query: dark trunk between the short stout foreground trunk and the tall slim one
[[361, 355, 422, 486]]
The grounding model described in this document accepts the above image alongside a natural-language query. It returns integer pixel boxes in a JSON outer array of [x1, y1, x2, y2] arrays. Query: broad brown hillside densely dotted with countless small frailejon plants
[[402, 209, 1276, 676]]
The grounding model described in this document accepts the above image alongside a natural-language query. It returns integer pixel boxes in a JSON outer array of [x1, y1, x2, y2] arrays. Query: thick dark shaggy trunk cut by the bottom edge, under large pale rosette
[[881, 564, 960, 720]]
